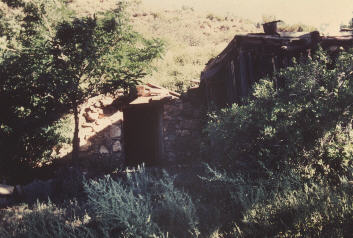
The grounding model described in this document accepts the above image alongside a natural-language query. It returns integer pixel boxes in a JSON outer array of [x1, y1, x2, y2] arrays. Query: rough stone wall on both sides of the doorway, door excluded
[[61, 87, 201, 165]]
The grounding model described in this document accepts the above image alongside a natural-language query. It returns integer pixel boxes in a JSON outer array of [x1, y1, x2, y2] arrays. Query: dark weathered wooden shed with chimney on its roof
[[200, 21, 353, 107]]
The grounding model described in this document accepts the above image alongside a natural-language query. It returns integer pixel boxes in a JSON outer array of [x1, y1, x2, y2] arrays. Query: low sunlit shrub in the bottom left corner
[[0, 201, 96, 238]]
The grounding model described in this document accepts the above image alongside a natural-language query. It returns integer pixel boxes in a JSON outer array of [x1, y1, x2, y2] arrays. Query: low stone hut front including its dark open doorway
[[26, 85, 203, 182]]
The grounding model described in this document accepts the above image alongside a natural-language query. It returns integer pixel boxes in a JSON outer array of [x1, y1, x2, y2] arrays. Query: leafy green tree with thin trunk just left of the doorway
[[52, 4, 162, 164]]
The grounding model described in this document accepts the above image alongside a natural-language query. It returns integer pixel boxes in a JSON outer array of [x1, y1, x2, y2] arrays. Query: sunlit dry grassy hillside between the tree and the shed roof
[[70, 0, 261, 92]]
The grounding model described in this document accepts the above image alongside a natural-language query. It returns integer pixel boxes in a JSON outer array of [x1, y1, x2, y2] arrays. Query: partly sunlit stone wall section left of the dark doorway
[[53, 94, 129, 171]]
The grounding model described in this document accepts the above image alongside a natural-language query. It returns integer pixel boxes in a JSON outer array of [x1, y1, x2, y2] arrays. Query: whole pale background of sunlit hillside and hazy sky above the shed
[[70, 0, 353, 92]]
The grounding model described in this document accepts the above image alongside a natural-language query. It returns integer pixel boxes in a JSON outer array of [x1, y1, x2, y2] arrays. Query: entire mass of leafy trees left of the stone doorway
[[0, 0, 162, 178]]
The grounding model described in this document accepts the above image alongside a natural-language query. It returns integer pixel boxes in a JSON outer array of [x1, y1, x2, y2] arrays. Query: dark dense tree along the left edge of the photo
[[0, 0, 69, 177]]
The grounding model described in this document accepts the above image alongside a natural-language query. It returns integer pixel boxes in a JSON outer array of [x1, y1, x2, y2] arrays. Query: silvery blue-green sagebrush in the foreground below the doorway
[[85, 166, 198, 237]]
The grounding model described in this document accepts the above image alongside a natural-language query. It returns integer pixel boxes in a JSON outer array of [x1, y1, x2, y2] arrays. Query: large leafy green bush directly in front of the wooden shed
[[206, 48, 353, 183]]
